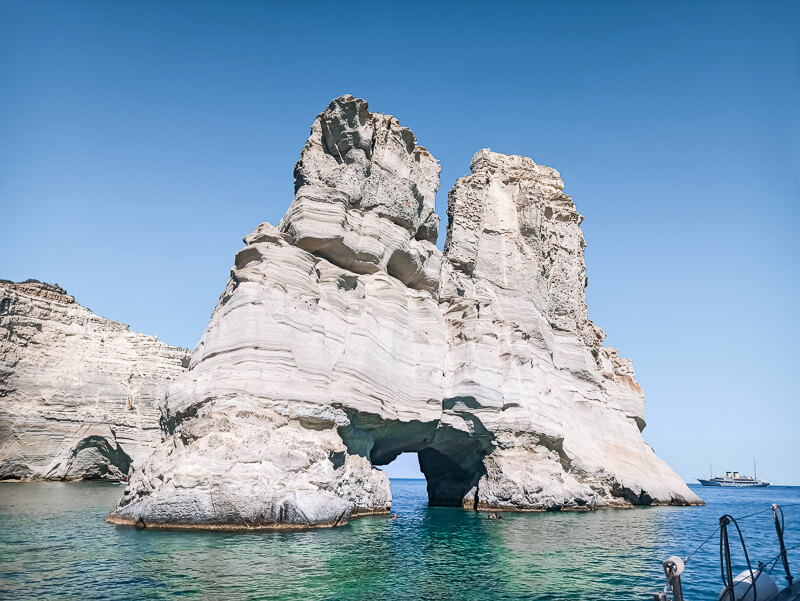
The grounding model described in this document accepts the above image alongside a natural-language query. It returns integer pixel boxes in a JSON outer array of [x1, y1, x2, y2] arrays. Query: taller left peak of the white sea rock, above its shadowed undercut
[[278, 96, 441, 291]]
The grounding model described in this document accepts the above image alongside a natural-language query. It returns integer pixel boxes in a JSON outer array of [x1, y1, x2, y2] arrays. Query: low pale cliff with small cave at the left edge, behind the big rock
[[0, 280, 189, 480]]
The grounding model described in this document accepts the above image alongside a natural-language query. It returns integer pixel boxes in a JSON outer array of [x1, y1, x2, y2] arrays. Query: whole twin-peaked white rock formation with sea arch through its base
[[109, 96, 701, 529]]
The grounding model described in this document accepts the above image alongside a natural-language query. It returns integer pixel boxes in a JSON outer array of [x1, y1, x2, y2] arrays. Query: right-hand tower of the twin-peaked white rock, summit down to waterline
[[439, 150, 684, 509]]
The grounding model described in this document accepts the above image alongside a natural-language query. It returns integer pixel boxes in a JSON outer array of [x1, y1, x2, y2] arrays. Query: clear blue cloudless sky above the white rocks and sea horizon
[[0, 0, 800, 484]]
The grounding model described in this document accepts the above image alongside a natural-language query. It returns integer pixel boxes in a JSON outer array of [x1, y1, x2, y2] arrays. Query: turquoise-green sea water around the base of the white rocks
[[0, 480, 800, 601]]
